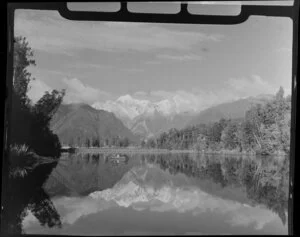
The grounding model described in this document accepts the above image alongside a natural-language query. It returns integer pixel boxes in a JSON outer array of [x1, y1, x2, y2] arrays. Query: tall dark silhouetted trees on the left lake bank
[[10, 37, 65, 157]]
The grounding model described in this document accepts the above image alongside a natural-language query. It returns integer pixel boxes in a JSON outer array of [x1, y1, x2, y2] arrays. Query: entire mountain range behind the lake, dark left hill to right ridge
[[50, 95, 272, 145]]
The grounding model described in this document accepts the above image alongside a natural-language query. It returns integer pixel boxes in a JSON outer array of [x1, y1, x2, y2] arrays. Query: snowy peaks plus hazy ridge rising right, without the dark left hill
[[92, 95, 272, 138]]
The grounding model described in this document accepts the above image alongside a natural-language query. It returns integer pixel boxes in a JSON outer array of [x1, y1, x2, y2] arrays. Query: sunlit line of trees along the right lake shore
[[141, 87, 291, 155]]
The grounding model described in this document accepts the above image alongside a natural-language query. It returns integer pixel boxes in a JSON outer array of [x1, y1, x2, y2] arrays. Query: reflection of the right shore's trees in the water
[[147, 154, 289, 225]]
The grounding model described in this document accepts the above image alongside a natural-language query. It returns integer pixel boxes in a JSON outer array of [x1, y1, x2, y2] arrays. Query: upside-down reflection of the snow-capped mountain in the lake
[[89, 164, 250, 212]]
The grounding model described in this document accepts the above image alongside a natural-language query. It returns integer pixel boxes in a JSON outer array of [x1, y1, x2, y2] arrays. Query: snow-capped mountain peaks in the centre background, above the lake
[[92, 95, 199, 137]]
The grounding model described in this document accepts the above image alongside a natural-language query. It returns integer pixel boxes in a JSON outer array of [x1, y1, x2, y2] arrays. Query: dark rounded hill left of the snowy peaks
[[51, 104, 137, 146]]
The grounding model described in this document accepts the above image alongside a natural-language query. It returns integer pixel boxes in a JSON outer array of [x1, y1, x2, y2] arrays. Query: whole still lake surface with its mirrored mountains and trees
[[3, 154, 289, 235]]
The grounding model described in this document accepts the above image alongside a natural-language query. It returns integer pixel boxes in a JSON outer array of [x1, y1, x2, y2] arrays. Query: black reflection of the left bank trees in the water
[[1, 162, 61, 234]]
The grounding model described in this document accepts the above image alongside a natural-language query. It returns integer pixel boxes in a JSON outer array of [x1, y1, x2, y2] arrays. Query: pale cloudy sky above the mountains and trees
[[15, 1, 292, 109]]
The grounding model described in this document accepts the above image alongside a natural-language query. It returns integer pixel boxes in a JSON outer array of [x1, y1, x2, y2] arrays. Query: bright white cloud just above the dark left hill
[[62, 78, 111, 104]]
